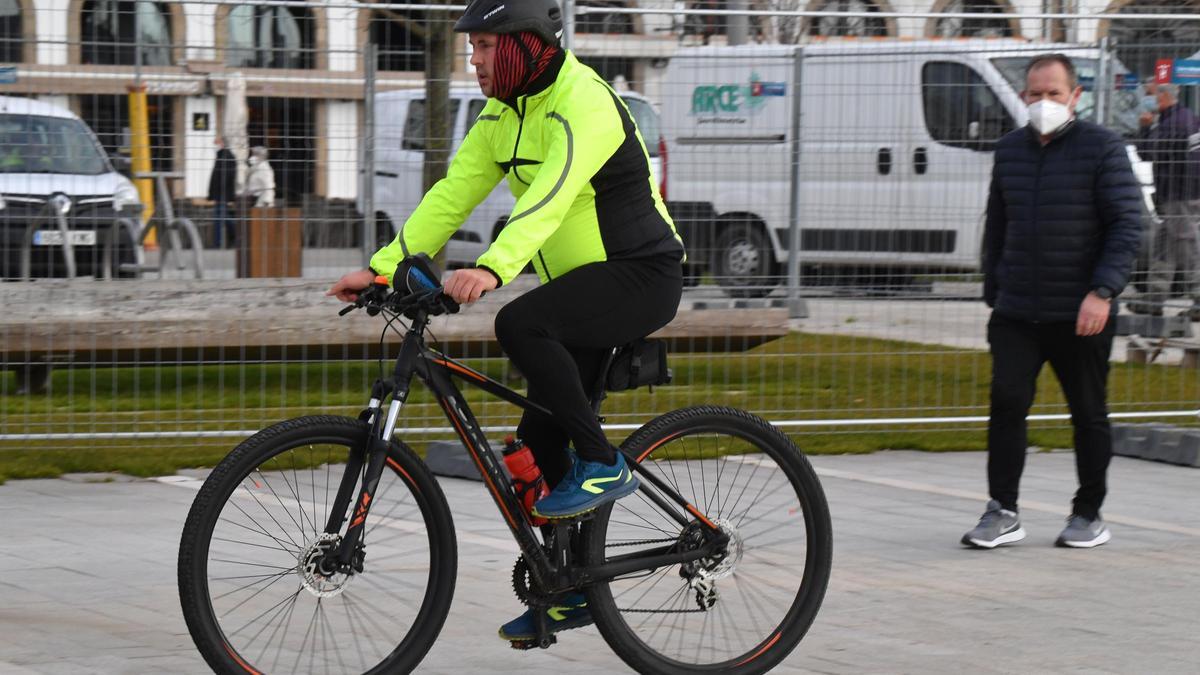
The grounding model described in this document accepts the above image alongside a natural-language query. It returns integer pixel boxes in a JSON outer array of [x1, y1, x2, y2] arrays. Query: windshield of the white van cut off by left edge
[[0, 114, 112, 175]]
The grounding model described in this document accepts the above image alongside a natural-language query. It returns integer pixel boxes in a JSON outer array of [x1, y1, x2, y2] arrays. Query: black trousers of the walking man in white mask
[[988, 312, 1116, 518]]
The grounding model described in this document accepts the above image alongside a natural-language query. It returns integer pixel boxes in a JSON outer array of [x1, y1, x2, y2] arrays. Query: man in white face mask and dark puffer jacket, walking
[[962, 54, 1141, 549]]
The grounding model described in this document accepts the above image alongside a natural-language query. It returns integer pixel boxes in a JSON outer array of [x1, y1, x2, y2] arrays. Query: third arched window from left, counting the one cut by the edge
[[226, 5, 316, 68]]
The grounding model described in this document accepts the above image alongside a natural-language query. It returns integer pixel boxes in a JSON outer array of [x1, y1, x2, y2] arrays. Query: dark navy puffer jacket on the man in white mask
[[983, 120, 1141, 322]]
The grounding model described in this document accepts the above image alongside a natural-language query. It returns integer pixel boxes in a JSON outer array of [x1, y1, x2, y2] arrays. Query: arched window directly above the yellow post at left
[[80, 0, 172, 66]]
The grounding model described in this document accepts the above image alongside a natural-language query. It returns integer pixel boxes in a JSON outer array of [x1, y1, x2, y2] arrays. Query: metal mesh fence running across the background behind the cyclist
[[0, 0, 1200, 476]]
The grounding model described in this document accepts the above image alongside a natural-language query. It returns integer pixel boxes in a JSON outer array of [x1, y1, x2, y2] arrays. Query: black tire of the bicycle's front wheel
[[178, 416, 457, 674]]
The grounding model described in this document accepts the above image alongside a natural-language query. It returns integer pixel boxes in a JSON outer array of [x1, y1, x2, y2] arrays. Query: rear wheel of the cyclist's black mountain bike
[[583, 406, 833, 674]]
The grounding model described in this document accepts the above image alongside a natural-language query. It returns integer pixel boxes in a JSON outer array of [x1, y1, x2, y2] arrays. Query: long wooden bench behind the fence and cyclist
[[0, 279, 788, 390]]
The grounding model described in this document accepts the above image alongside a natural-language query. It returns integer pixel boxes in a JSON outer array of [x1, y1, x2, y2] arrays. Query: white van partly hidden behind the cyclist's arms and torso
[[359, 85, 666, 267]]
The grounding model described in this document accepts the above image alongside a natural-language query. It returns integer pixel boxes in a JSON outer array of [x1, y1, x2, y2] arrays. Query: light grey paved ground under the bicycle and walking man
[[0, 452, 1200, 675]]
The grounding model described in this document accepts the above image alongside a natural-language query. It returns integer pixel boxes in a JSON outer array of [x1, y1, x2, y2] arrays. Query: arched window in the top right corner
[[1109, 0, 1200, 78]]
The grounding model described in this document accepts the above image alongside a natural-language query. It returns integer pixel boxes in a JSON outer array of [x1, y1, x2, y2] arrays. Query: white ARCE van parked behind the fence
[[662, 40, 1140, 295]]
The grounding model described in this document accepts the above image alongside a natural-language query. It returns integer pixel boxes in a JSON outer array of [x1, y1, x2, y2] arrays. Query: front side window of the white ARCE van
[[920, 61, 1014, 150]]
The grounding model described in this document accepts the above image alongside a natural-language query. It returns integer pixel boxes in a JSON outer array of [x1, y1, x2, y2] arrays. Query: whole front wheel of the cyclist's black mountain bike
[[179, 417, 457, 674]]
